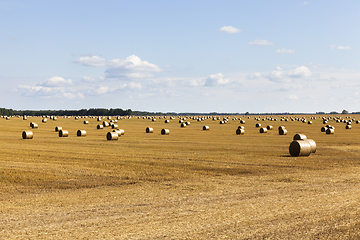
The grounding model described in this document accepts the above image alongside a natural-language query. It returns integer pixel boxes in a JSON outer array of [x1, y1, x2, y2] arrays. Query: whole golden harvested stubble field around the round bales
[[0, 115, 360, 239]]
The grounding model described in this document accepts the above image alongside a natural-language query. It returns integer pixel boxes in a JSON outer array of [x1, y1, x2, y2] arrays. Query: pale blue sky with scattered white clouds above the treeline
[[0, 0, 360, 113]]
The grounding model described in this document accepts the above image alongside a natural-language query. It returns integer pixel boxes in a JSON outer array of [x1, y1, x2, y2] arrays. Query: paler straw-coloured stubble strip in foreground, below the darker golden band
[[0, 173, 360, 239]]
